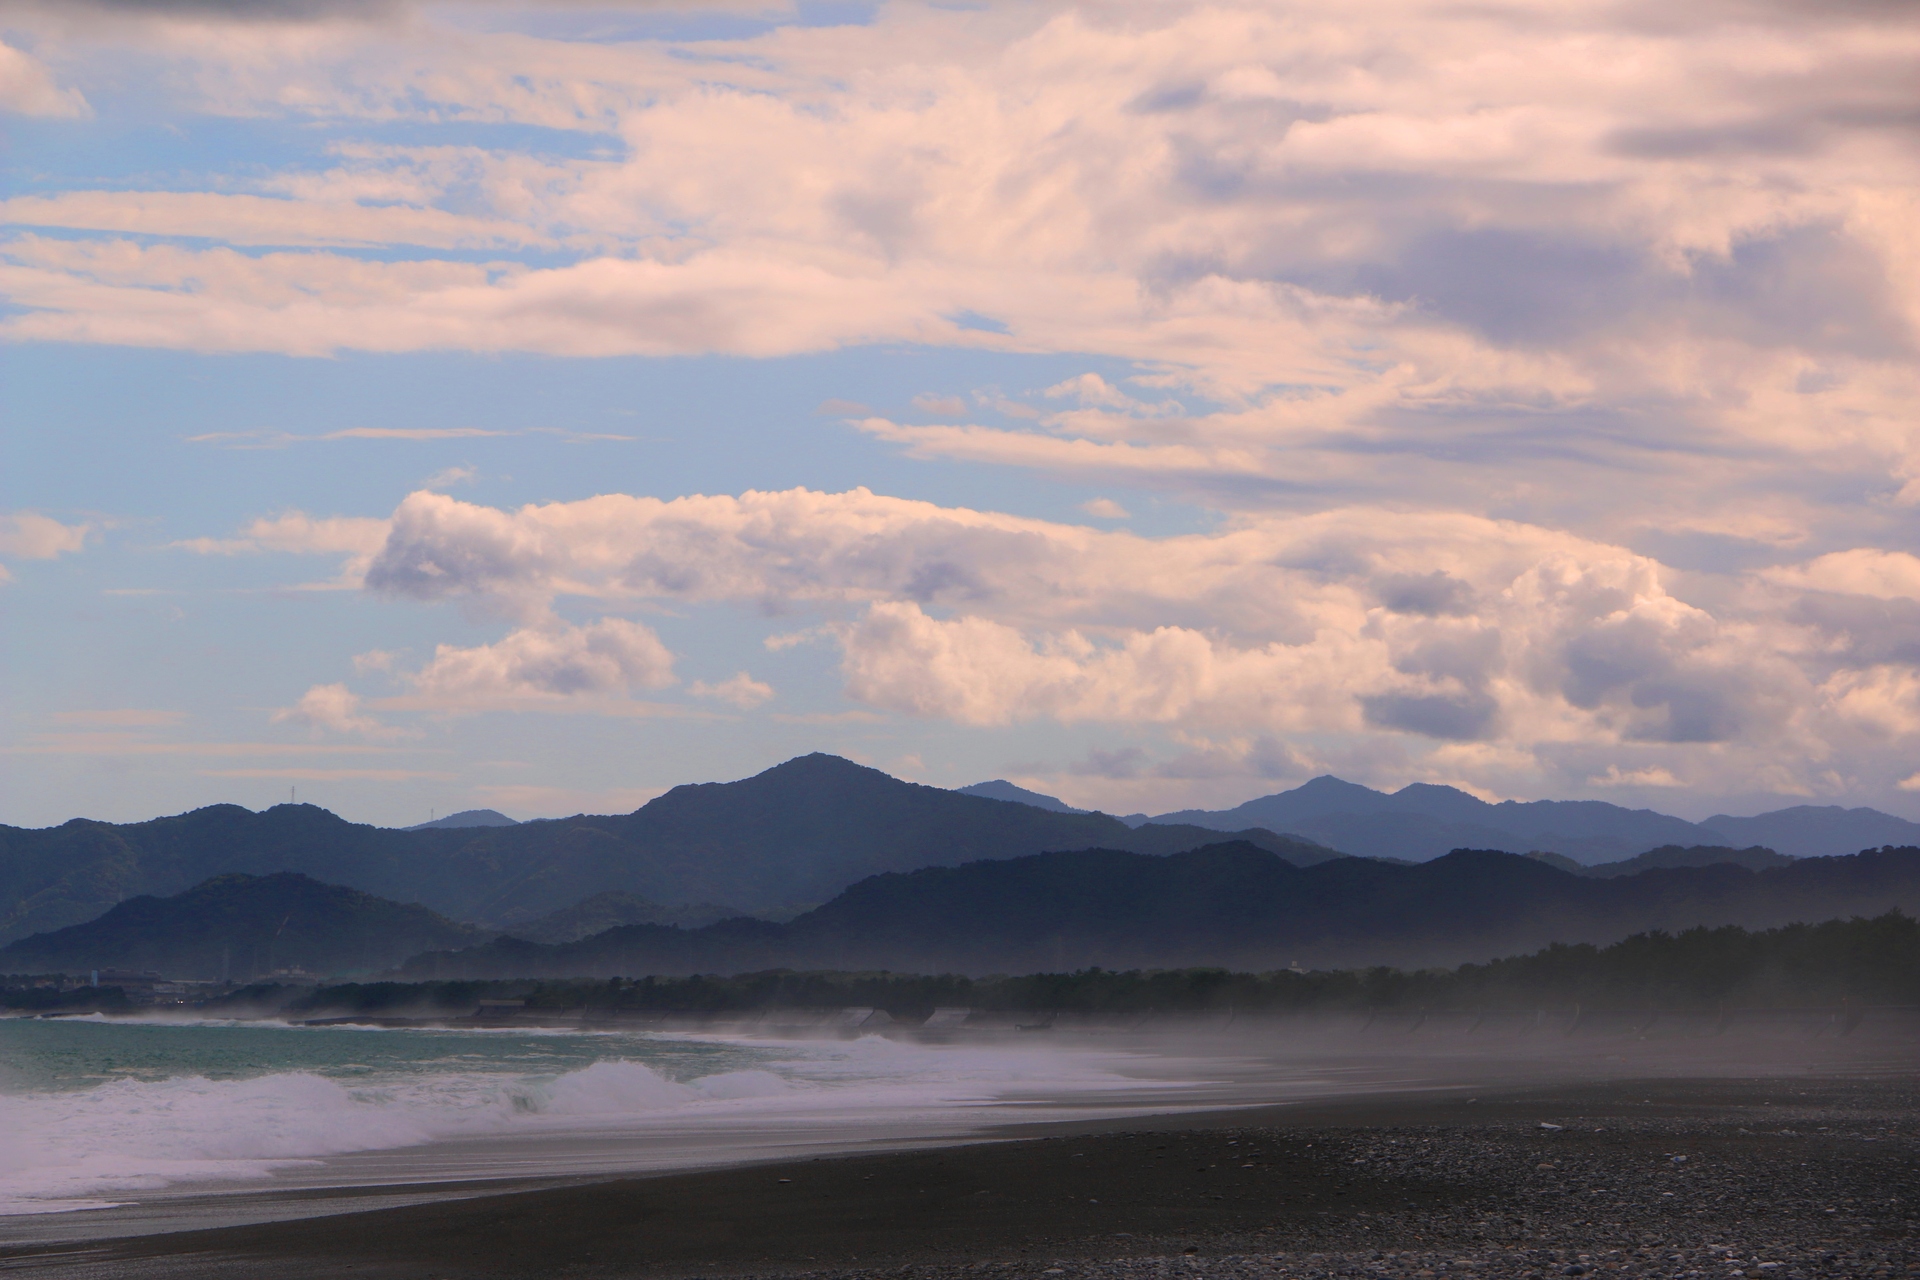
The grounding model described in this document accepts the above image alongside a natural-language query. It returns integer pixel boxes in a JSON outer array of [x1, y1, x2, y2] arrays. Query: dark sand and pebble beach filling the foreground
[[0, 1075, 1920, 1280]]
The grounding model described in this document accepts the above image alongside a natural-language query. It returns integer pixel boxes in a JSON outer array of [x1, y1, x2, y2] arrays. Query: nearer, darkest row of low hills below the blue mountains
[[18, 841, 1920, 981]]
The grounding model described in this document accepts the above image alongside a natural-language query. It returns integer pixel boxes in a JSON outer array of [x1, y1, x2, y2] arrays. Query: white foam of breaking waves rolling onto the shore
[[0, 1038, 1182, 1215]]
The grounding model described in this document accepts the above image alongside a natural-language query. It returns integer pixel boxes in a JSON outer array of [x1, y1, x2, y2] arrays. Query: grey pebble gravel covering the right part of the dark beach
[[721, 1080, 1920, 1280]]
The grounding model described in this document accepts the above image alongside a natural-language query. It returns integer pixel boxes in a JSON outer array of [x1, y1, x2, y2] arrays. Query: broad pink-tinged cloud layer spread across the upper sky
[[0, 0, 1920, 549]]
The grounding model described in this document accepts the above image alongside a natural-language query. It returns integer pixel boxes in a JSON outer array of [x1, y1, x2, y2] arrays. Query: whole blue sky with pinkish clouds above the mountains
[[0, 0, 1920, 825]]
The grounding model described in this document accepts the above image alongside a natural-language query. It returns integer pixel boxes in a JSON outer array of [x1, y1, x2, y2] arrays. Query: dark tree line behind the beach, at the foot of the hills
[[0, 912, 1920, 1021]]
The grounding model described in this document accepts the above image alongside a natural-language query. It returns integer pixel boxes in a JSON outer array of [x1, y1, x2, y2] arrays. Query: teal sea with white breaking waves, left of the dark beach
[[0, 1017, 1198, 1234]]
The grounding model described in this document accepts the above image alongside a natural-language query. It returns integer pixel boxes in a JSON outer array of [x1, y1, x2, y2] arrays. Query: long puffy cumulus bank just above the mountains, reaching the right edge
[[307, 489, 1920, 794]]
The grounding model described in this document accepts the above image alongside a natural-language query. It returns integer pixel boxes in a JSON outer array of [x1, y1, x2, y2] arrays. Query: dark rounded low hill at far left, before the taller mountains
[[0, 871, 490, 981]]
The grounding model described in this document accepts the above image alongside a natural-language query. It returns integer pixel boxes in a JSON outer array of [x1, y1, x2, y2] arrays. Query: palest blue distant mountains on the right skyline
[[1150, 777, 1920, 864]]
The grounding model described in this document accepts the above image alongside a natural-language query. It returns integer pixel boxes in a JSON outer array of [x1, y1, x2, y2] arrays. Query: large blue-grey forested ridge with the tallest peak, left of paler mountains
[[0, 754, 1336, 942]]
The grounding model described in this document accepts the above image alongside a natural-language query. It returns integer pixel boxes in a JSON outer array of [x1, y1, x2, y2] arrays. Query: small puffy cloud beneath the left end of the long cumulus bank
[[409, 618, 674, 710]]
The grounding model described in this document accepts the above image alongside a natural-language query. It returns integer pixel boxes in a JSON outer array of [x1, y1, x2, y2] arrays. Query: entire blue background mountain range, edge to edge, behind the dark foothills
[[15, 754, 1920, 944]]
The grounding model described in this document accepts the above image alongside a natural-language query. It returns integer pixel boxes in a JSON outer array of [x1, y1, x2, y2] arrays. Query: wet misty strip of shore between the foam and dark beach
[[0, 1015, 1920, 1247]]
